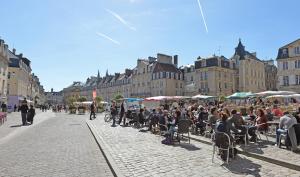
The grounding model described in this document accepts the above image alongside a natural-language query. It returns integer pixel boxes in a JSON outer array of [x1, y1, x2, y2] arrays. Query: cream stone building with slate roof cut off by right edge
[[277, 39, 300, 93]]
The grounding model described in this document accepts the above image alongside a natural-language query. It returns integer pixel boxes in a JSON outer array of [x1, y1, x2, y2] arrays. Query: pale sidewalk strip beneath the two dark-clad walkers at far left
[[0, 110, 55, 143]]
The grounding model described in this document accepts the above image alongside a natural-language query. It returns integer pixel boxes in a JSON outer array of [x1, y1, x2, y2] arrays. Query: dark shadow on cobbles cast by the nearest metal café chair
[[222, 156, 262, 177]]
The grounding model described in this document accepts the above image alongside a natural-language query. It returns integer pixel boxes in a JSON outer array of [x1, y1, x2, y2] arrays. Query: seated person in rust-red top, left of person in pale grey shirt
[[248, 109, 268, 142]]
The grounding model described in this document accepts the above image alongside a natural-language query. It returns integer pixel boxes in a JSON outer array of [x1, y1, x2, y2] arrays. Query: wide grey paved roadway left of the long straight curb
[[0, 113, 113, 177]]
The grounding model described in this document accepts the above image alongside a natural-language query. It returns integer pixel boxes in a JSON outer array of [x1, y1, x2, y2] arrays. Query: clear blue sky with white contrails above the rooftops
[[0, 0, 300, 90]]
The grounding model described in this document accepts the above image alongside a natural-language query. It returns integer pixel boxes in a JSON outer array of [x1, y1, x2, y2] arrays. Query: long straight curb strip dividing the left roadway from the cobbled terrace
[[86, 121, 124, 177]]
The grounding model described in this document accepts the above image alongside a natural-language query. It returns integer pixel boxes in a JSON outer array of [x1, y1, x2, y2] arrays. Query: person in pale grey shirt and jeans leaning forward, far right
[[276, 112, 299, 152]]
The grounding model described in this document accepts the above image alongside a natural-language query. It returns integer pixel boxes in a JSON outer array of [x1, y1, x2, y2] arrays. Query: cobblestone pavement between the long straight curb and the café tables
[[88, 115, 300, 177]]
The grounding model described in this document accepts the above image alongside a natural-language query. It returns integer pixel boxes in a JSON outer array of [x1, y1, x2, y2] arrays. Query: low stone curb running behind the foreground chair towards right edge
[[184, 136, 300, 171]]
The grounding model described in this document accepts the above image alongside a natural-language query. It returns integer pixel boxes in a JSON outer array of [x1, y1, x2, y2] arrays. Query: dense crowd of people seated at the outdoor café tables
[[106, 100, 300, 160]]
